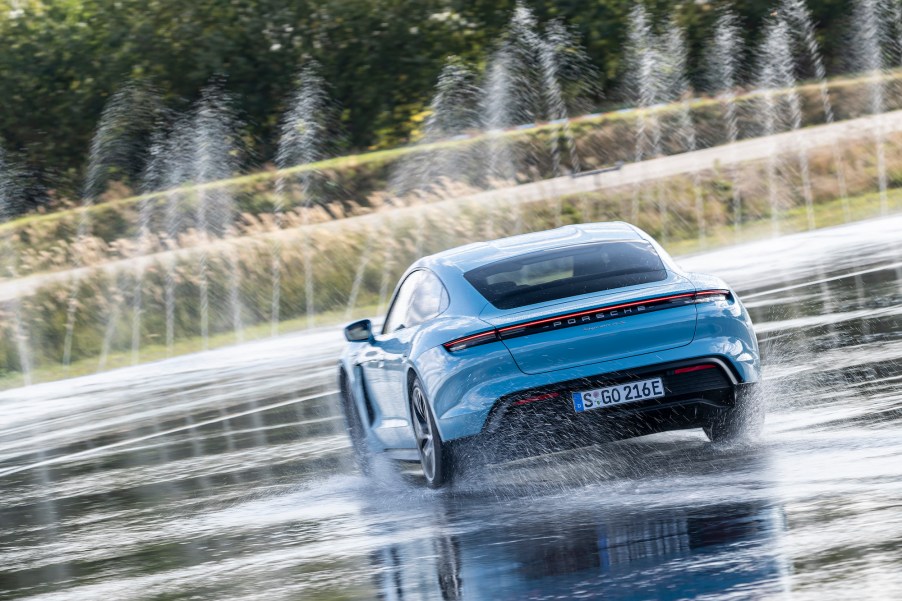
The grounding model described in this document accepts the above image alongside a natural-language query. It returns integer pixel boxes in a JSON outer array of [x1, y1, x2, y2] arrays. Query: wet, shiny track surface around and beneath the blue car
[[0, 217, 902, 601]]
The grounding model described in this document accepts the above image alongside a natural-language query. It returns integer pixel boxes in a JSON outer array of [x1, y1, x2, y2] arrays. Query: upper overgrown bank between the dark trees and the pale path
[[0, 74, 902, 277]]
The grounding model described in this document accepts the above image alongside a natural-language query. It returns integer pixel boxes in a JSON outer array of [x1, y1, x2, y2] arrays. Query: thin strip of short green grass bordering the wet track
[[0, 189, 902, 390]]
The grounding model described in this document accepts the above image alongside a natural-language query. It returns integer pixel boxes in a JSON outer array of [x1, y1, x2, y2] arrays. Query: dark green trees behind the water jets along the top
[[0, 0, 849, 203]]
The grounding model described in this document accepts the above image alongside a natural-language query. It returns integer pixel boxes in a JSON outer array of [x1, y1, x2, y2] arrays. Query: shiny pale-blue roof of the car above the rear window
[[412, 221, 644, 272]]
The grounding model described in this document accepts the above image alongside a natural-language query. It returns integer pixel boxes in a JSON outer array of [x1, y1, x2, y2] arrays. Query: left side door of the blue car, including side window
[[361, 269, 448, 443]]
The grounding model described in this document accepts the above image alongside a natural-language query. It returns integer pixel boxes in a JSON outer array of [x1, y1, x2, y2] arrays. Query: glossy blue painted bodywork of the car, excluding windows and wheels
[[341, 223, 760, 450]]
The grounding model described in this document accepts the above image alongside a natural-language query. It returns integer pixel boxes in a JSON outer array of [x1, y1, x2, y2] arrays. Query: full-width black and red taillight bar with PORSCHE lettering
[[442, 289, 730, 353]]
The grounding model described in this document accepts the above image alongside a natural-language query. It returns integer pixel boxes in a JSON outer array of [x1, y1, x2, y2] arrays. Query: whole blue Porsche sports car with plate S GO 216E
[[339, 223, 763, 487]]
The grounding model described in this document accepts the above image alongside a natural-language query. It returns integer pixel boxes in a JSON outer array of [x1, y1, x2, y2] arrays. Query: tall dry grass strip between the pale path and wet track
[[0, 128, 902, 378]]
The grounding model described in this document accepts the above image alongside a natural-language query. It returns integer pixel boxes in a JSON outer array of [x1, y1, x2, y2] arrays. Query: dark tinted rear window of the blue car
[[464, 240, 667, 309]]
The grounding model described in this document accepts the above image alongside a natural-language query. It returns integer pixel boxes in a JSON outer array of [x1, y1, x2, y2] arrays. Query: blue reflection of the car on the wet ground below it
[[371, 502, 788, 601]]
